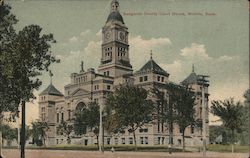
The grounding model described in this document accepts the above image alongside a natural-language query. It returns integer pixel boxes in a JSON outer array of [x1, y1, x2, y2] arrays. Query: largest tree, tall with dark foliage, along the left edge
[[0, 3, 58, 158]]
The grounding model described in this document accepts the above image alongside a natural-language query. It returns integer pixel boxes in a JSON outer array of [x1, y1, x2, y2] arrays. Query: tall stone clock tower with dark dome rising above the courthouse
[[98, 0, 133, 77]]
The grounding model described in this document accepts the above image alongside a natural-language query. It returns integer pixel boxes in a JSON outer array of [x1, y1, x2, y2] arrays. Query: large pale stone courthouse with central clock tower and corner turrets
[[39, 0, 208, 145]]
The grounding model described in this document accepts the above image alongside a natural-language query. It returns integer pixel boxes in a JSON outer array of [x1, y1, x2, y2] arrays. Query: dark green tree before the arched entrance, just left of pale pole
[[74, 102, 100, 145]]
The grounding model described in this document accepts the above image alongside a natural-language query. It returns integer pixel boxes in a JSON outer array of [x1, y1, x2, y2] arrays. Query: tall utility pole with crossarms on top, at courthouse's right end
[[198, 75, 209, 157]]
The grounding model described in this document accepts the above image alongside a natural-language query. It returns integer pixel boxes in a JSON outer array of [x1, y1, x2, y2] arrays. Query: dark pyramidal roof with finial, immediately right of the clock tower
[[138, 57, 169, 76]]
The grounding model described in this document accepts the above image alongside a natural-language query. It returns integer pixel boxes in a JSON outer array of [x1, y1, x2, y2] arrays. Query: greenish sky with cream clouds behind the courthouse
[[6, 0, 249, 126]]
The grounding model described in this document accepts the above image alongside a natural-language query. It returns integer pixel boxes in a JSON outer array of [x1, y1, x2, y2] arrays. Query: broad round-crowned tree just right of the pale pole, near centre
[[106, 85, 154, 150]]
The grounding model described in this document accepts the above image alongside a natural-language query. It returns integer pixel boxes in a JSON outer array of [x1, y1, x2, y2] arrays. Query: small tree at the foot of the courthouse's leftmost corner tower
[[31, 121, 49, 146]]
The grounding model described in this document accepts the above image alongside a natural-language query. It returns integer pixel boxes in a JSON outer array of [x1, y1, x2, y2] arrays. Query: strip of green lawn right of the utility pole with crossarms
[[208, 144, 248, 153]]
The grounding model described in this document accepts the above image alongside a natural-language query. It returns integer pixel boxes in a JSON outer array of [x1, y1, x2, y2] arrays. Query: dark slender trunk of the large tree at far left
[[21, 101, 26, 158]]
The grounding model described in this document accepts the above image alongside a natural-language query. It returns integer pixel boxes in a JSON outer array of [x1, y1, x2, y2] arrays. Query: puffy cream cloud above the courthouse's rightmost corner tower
[[181, 43, 211, 59]]
